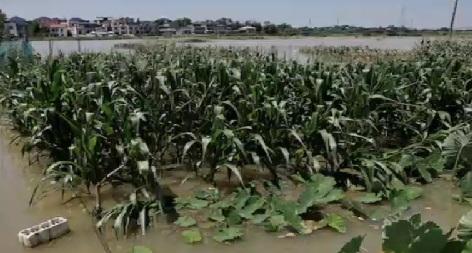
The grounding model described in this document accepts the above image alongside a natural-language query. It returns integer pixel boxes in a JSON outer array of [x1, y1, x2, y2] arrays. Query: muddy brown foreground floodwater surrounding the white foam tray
[[0, 123, 470, 253]]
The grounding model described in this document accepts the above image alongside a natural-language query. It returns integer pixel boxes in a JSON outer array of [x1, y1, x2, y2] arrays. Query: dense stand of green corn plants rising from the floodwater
[[0, 42, 472, 242]]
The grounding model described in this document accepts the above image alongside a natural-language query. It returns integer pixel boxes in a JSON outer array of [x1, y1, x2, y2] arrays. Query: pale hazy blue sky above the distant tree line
[[0, 0, 472, 27]]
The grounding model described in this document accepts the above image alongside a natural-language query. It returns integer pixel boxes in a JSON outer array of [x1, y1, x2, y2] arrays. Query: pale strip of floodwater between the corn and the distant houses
[[31, 36, 472, 58]]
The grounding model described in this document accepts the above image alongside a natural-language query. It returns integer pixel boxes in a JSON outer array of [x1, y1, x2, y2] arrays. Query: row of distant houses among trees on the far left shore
[[0, 11, 262, 37]]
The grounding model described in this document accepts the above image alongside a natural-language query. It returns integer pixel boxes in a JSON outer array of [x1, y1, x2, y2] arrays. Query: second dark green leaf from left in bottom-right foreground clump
[[382, 220, 414, 253]]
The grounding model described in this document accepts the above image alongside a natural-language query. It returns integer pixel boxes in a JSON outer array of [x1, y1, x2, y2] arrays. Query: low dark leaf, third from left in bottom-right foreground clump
[[408, 228, 448, 253]]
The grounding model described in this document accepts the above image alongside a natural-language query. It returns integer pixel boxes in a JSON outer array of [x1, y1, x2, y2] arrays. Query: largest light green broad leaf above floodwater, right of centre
[[298, 175, 344, 214]]
